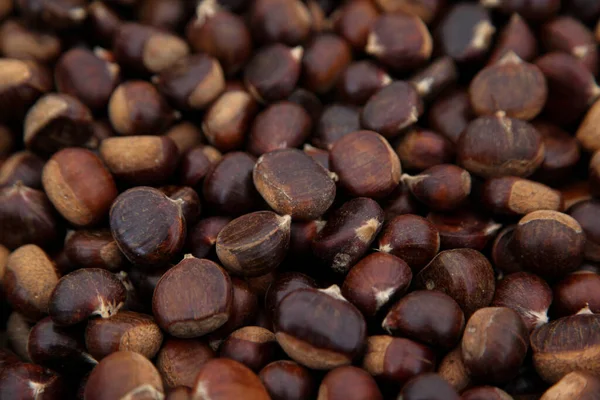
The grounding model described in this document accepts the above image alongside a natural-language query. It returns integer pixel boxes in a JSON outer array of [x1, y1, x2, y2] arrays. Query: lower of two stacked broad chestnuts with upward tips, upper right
[[456, 111, 545, 178]]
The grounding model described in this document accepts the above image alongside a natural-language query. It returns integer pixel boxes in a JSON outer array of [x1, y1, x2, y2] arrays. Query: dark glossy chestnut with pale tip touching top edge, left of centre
[[186, 0, 252, 76]]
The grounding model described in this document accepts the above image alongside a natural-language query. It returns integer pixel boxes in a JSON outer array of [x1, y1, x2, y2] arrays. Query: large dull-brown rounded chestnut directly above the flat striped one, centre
[[253, 149, 336, 220]]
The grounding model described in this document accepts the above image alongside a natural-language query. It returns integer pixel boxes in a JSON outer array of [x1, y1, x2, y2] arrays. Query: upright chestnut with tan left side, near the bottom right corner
[[461, 307, 529, 383]]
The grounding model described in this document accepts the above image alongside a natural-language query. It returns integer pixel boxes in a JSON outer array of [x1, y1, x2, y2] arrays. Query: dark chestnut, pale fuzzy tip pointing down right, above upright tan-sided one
[[491, 272, 552, 332]]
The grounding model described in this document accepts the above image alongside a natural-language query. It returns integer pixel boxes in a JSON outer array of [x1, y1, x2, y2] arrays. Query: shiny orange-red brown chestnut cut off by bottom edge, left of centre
[[193, 358, 270, 400]]
